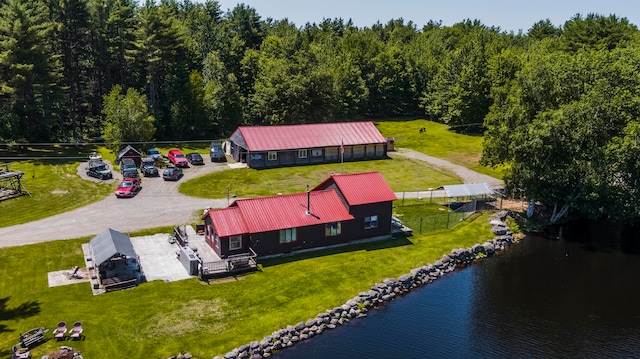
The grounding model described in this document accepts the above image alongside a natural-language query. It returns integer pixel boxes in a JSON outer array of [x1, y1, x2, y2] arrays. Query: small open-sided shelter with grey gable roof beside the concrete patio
[[89, 228, 142, 291]]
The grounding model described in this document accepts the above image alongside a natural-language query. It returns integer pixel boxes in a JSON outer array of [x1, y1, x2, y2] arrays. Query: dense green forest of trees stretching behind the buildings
[[0, 0, 640, 224]]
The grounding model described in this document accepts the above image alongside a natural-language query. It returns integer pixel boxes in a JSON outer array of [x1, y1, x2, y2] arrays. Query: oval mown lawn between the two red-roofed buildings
[[179, 154, 460, 198]]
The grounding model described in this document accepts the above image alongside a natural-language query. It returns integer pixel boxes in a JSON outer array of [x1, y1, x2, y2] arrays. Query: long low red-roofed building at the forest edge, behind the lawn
[[228, 121, 387, 168]]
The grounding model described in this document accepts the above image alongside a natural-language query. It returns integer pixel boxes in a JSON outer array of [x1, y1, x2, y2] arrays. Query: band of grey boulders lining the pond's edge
[[170, 211, 515, 359]]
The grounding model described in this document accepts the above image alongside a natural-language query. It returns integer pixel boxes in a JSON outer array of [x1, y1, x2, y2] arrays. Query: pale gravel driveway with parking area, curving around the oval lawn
[[0, 149, 502, 247]]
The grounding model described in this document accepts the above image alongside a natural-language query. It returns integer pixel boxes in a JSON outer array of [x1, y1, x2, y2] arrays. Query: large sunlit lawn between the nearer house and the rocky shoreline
[[0, 214, 492, 358]]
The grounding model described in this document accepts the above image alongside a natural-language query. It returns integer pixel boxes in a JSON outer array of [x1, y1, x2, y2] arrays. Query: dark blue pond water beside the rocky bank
[[273, 231, 640, 359]]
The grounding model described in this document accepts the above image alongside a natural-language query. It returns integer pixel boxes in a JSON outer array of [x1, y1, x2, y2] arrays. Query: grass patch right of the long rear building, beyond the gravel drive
[[376, 119, 503, 178]]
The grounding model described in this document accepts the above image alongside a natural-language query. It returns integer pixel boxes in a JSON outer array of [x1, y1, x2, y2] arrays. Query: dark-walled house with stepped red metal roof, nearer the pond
[[202, 172, 397, 259]]
